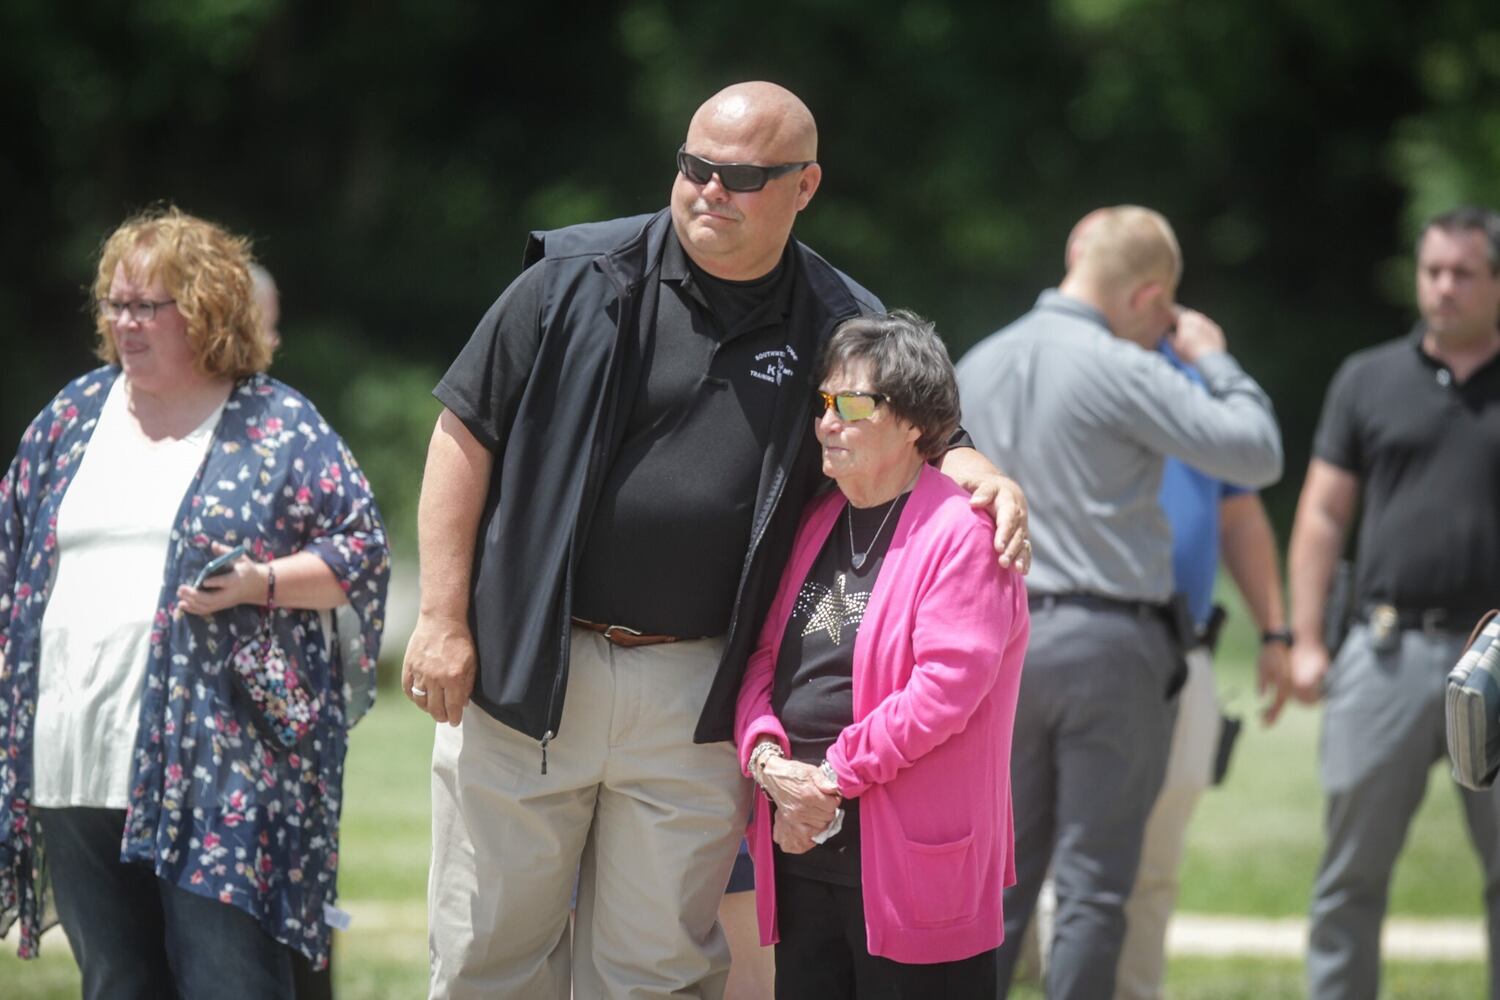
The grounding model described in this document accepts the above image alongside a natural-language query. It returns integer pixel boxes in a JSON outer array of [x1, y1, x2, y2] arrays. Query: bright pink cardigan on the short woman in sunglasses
[[735, 466, 1029, 964]]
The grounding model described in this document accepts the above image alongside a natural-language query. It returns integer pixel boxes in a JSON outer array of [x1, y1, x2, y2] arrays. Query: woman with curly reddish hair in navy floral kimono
[[0, 208, 389, 997]]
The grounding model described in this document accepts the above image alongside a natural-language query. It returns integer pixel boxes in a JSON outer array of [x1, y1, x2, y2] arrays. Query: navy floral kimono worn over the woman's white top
[[0, 367, 390, 967]]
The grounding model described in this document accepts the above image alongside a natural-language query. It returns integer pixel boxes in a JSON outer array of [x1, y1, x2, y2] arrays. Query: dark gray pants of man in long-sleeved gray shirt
[[999, 603, 1178, 1000]]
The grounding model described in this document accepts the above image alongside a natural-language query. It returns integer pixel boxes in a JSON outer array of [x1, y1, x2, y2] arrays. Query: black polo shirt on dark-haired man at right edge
[[1313, 327, 1500, 621]]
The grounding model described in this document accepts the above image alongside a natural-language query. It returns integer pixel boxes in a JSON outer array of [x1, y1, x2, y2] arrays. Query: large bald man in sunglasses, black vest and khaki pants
[[402, 82, 1028, 1000]]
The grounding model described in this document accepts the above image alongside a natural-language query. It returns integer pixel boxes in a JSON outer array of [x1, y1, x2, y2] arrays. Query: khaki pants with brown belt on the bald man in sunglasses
[[428, 628, 750, 1000]]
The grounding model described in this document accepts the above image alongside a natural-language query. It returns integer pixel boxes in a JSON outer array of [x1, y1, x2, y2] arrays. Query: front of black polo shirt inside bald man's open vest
[[573, 237, 810, 636]]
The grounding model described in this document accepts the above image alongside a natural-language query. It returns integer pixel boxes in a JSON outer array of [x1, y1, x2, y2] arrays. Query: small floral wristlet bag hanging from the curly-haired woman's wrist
[[230, 564, 318, 750]]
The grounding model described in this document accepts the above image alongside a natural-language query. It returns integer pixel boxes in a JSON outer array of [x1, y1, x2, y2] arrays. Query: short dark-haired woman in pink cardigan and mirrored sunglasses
[[737, 312, 1028, 1000]]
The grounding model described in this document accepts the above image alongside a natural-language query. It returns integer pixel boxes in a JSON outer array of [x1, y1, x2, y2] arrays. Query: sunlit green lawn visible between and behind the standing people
[[0, 581, 1487, 1000]]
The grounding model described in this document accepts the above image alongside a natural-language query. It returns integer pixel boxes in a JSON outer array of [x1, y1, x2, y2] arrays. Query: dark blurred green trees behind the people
[[0, 0, 1500, 548]]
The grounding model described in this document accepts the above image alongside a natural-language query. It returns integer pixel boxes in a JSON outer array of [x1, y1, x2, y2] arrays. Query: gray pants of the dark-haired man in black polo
[[1307, 625, 1500, 1000]]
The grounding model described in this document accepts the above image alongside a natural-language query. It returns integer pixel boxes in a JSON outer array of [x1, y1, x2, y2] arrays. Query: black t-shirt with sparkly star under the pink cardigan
[[771, 493, 911, 886]]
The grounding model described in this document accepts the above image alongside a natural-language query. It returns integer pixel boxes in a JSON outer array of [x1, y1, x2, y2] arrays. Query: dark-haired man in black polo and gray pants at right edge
[[1289, 208, 1500, 1000]]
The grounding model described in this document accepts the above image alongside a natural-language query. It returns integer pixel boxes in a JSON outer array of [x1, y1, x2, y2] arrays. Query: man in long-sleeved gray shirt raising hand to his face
[[959, 205, 1281, 1000]]
